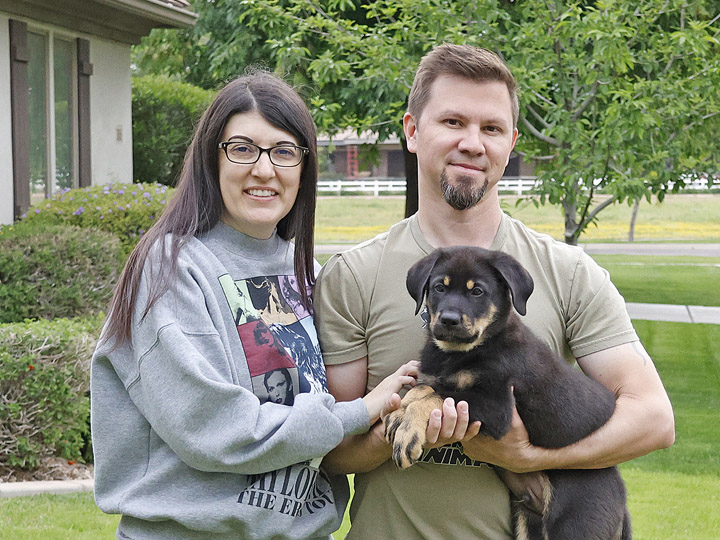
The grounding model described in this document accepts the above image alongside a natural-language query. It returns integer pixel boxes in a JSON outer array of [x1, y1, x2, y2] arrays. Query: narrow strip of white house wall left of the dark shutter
[[0, 14, 13, 224]]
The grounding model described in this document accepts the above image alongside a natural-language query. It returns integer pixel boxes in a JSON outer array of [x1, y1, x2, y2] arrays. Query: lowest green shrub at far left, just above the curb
[[0, 316, 102, 472]]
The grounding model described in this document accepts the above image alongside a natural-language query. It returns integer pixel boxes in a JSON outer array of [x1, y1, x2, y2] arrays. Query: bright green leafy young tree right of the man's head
[[507, 0, 720, 243]]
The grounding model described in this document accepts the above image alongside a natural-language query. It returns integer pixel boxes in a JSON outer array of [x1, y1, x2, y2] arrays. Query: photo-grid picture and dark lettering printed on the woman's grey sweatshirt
[[219, 274, 335, 518]]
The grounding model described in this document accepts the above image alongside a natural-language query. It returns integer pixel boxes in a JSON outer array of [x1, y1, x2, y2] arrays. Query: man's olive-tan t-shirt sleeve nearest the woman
[[313, 254, 368, 365]]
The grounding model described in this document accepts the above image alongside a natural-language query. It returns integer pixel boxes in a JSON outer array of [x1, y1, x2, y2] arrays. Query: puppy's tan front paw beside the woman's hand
[[385, 385, 443, 469]]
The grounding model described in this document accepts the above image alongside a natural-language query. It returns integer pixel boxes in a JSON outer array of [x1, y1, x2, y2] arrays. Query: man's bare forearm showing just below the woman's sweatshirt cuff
[[323, 422, 392, 474]]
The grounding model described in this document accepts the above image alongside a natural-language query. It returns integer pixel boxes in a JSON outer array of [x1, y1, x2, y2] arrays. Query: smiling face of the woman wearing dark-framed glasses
[[218, 111, 303, 239]]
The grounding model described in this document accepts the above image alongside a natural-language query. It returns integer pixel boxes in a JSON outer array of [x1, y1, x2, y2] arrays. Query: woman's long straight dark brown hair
[[103, 71, 317, 346]]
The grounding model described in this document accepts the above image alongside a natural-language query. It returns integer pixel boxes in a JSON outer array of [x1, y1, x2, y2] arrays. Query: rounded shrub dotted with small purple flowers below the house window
[[23, 184, 174, 253]]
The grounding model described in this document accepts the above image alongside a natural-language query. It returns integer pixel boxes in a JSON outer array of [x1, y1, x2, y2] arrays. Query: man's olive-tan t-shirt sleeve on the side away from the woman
[[566, 253, 638, 357]]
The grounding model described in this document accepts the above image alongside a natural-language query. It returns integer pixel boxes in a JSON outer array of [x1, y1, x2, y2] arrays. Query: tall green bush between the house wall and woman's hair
[[132, 75, 215, 186]]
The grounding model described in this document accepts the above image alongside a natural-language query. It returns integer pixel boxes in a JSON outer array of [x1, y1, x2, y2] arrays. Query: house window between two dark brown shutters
[[27, 31, 78, 204]]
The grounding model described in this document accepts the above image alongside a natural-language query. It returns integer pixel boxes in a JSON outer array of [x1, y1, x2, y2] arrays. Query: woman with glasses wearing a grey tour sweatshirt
[[91, 73, 417, 540]]
